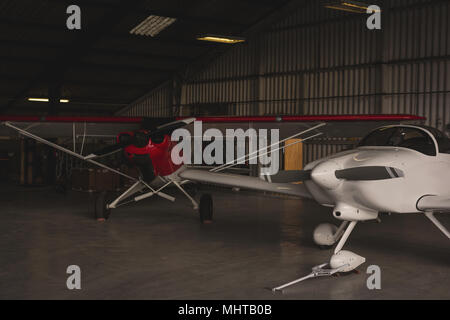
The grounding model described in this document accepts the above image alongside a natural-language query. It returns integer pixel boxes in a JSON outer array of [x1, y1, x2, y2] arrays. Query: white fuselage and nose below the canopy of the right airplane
[[305, 139, 450, 216]]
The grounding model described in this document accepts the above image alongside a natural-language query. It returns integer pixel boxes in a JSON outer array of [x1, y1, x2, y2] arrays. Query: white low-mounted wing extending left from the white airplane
[[180, 169, 312, 198]]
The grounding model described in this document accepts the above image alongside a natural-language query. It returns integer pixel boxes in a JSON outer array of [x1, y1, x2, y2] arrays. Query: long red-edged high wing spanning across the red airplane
[[0, 114, 425, 138]]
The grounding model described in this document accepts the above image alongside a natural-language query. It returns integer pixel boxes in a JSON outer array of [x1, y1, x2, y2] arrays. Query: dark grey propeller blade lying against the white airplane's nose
[[335, 166, 405, 181]]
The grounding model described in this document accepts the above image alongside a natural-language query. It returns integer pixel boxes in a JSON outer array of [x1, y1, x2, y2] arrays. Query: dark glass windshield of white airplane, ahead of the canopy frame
[[359, 127, 437, 156]]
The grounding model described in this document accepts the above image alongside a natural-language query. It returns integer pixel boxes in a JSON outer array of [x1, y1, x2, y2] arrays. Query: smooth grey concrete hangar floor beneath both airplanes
[[0, 186, 450, 299]]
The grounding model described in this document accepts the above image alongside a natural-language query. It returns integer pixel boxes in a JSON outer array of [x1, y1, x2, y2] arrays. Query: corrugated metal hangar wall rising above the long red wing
[[120, 0, 450, 127]]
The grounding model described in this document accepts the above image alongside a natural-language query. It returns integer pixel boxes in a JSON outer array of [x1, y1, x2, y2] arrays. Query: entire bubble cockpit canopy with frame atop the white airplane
[[358, 126, 450, 156]]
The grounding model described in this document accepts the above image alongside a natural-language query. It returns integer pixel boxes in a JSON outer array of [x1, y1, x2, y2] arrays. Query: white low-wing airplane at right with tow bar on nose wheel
[[181, 125, 450, 291]]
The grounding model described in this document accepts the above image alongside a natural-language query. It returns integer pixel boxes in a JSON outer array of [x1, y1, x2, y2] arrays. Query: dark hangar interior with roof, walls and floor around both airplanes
[[0, 0, 450, 299]]
